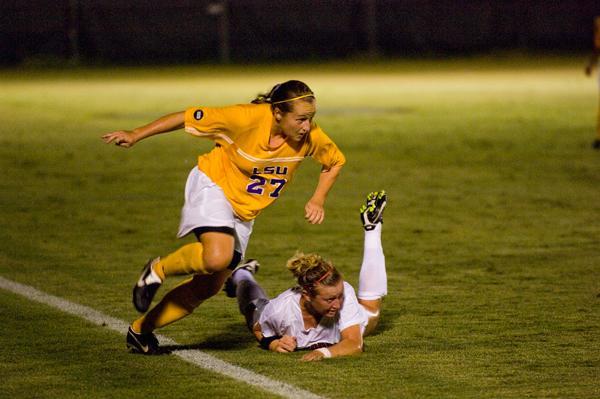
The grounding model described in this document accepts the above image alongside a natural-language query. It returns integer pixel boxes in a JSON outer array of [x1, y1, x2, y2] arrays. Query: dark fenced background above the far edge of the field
[[0, 0, 600, 65]]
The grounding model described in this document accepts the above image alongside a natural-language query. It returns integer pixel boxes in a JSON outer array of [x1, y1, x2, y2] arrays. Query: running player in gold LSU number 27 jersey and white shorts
[[102, 80, 346, 354]]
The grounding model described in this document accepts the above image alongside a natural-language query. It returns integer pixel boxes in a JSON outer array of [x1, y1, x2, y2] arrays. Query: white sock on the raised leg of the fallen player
[[358, 223, 387, 300]]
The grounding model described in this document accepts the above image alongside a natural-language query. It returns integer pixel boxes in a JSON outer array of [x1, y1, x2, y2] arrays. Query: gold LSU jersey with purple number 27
[[185, 104, 346, 221]]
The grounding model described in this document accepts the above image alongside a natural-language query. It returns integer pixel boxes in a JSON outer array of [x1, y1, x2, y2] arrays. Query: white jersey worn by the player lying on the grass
[[258, 281, 369, 349]]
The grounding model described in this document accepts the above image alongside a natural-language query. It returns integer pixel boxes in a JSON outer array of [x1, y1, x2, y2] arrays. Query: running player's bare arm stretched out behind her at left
[[102, 112, 185, 148]]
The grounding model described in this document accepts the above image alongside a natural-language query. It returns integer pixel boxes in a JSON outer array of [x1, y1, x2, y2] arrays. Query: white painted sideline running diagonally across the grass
[[0, 276, 323, 399]]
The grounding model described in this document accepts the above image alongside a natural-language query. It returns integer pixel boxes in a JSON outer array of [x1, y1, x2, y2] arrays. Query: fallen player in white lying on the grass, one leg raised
[[225, 191, 387, 361]]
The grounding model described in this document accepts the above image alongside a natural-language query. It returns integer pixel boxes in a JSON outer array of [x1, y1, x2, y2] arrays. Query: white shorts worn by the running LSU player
[[177, 166, 254, 259]]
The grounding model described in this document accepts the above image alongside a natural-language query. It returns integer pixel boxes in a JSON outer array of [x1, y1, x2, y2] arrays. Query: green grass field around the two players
[[0, 57, 600, 398]]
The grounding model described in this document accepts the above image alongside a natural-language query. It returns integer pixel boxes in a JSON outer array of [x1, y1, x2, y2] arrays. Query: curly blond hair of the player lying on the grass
[[286, 252, 342, 296]]
